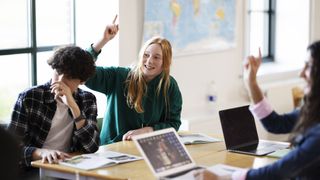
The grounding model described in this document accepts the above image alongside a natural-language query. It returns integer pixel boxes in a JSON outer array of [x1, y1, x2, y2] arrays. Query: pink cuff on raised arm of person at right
[[249, 97, 273, 120]]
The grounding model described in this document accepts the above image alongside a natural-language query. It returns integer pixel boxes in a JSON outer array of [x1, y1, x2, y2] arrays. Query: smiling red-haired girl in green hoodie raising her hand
[[86, 15, 182, 144]]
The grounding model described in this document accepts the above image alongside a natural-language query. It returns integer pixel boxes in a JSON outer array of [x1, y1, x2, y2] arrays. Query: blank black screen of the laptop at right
[[219, 105, 259, 149]]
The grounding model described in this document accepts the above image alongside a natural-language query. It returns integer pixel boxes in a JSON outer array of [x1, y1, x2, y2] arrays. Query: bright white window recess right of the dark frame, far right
[[275, 0, 310, 66]]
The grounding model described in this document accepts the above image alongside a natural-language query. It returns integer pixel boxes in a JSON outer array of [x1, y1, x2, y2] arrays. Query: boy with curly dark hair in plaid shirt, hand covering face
[[8, 46, 99, 175]]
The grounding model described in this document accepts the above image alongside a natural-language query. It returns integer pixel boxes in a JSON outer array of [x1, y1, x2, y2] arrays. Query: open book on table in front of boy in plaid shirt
[[59, 151, 142, 170]]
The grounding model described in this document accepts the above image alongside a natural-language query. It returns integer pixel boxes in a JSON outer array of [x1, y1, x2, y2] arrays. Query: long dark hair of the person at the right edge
[[290, 41, 320, 142]]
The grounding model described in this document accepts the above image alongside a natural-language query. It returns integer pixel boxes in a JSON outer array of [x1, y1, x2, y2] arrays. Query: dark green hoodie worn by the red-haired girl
[[86, 48, 182, 145]]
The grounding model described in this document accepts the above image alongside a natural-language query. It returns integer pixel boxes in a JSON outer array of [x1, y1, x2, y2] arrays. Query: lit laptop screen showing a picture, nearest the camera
[[136, 131, 193, 173]]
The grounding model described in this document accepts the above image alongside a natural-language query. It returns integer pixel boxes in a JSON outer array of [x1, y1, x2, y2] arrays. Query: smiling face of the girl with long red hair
[[141, 44, 163, 82]]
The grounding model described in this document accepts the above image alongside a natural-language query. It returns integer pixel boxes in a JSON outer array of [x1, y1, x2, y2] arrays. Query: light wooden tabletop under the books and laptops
[[32, 138, 277, 179]]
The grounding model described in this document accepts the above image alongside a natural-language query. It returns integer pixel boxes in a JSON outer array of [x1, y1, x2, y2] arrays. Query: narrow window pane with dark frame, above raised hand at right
[[248, 0, 275, 61]]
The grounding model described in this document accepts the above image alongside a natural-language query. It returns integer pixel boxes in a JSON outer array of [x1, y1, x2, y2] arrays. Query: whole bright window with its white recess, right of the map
[[247, 0, 310, 77]]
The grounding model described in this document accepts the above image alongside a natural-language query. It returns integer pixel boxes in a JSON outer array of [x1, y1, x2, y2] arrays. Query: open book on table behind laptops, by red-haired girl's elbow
[[179, 133, 221, 144]]
